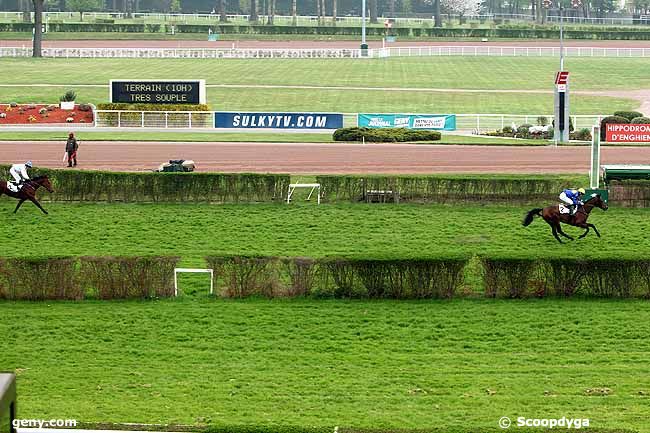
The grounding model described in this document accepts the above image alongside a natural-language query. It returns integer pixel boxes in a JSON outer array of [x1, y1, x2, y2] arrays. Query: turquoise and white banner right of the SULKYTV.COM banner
[[357, 114, 456, 131]]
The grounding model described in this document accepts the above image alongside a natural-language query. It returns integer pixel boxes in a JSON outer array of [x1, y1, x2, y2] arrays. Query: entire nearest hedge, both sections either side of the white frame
[[0, 256, 650, 300]]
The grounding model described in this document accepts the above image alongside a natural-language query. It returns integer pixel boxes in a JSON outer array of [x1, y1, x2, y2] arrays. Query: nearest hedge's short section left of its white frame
[[0, 257, 179, 301]]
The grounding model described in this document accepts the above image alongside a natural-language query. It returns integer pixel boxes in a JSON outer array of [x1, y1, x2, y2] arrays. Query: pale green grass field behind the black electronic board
[[0, 57, 636, 114]]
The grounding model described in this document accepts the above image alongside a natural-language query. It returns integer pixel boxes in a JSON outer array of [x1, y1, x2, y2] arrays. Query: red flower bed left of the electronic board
[[0, 104, 93, 125]]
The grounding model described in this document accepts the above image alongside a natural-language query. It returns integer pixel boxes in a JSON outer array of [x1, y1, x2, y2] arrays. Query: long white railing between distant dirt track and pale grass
[[5, 45, 650, 59]]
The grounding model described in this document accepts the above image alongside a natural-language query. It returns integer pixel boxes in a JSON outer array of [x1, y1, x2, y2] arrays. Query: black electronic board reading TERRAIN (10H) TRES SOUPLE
[[109, 80, 206, 104]]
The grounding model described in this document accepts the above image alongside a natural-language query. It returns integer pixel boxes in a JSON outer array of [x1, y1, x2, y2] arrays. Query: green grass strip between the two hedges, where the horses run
[[0, 198, 636, 264]]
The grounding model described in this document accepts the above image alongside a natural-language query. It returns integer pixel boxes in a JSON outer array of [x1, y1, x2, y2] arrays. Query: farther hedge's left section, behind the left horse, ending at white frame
[[0, 166, 290, 203]]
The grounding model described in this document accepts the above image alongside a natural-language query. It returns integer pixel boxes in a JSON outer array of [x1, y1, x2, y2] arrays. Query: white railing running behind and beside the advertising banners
[[95, 110, 605, 132]]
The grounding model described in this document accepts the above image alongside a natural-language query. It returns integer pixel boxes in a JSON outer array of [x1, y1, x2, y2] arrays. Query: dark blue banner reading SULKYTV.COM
[[214, 112, 343, 129]]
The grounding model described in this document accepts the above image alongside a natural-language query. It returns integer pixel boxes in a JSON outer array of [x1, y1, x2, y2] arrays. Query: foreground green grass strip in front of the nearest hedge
[[0, 299, 650, 433]]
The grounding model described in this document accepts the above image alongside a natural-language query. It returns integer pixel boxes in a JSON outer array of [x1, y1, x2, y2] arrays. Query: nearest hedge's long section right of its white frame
[[206, 256, 650, 299]]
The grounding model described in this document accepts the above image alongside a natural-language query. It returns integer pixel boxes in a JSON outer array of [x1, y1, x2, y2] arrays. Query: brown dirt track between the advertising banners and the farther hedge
[[0, 141, 650, 174]]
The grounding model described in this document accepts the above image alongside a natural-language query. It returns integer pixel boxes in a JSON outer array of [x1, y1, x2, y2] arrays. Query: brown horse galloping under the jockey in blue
[[521, 194, 608, 243]]
